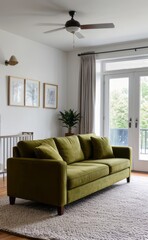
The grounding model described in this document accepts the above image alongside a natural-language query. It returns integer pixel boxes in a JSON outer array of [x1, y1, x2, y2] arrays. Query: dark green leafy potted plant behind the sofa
[[59, 109, 80, 136]]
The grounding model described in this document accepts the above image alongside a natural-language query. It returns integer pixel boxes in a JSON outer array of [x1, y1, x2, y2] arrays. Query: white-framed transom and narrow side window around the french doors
[[95, 57, 148, 135]]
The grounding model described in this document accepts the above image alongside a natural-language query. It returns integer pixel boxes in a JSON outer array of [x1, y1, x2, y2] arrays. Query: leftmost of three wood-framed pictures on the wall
[[8, 76, 25, 106]]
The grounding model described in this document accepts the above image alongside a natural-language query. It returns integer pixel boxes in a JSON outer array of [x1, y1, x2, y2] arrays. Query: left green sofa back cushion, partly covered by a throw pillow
[[17, 138, 57, 158]]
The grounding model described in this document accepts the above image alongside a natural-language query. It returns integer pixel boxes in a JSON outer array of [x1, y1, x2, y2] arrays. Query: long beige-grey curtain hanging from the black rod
[[80, 54, 96, 134]]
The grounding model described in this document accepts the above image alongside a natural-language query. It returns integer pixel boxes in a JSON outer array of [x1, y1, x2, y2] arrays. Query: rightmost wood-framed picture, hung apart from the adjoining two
[[43, 83, 58, 109]]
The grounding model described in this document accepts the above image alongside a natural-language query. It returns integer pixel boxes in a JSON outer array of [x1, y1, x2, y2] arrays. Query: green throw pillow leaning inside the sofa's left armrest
[[34, 144, 63, 161]]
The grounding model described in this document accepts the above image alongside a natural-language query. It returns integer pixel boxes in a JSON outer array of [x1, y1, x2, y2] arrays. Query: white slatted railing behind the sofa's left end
[[0, 132, 33, 176]]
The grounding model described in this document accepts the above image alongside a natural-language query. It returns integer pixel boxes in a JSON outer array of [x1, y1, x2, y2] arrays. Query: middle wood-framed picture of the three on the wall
[[25, 79, 40, 107]]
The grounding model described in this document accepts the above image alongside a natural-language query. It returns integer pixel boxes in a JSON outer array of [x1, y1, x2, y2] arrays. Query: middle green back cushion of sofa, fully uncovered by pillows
[[54, 136, 84, 164]]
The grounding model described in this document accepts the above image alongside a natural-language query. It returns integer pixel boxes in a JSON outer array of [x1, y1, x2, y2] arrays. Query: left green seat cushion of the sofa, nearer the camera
[[67, 162, 109, 190]]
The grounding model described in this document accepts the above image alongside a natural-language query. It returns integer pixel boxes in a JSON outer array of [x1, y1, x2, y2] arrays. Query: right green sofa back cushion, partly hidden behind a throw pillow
[[78, 133, 96, 160]]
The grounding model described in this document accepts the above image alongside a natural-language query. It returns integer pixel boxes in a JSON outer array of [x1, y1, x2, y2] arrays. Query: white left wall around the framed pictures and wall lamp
[[0, 30, 67, 139]]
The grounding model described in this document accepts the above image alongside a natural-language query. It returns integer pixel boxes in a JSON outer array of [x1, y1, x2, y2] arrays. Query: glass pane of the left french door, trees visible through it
[[109, 77, 129, 146]]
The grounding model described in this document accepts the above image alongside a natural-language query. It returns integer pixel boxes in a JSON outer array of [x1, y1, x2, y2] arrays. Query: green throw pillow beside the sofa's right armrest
[[91, 137, 114, 159]]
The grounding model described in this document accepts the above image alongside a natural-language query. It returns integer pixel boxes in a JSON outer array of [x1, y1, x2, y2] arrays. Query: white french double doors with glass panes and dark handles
[[104, 72, 148, 171]]
